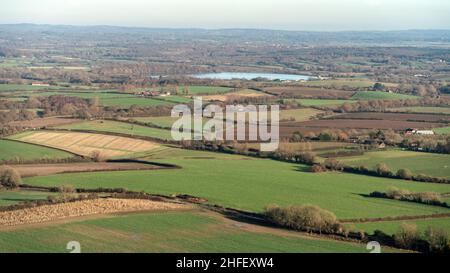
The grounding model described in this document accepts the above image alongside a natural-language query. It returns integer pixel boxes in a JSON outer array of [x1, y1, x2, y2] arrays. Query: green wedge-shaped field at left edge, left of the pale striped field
[[0, 139, 73, 162]]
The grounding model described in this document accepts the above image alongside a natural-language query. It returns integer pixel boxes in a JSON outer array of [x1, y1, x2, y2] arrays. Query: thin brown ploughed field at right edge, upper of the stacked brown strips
[[331, 113, 450, 122]]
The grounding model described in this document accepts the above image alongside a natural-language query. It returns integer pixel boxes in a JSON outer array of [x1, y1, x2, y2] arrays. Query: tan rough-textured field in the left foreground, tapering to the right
[[0, 199, 191, 226]]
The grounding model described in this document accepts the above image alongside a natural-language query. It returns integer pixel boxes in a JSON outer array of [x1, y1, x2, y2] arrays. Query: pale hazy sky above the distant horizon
[[0, 0, 450, 30]]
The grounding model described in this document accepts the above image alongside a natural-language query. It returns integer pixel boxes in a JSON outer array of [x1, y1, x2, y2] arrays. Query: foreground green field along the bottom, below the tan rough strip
[[0, 212, 367, 253]]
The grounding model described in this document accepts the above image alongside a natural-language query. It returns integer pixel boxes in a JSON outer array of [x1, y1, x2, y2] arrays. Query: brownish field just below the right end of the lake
[[264, 86, 355, 99]]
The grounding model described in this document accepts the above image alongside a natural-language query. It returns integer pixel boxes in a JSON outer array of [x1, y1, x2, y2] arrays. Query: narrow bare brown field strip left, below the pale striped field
[[10, 162, 162, 177]]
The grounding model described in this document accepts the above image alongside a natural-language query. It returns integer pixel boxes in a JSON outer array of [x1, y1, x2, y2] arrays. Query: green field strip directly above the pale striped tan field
[[58, 120, 172, 140]]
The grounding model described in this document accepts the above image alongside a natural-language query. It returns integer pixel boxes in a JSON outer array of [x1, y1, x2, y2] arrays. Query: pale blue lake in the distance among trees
[[193, 72, 312, 81]]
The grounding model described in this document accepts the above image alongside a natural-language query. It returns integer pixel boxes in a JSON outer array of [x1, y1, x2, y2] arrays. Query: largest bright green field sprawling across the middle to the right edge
[[25, 148, 450, 218]]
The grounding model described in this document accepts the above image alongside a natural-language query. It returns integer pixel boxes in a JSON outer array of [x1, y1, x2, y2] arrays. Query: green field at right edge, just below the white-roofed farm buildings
[[339, 150, 450, 177]]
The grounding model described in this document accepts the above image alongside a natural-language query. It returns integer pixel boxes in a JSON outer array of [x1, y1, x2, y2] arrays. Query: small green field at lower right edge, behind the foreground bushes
[[346, 218, 450, 235]]
